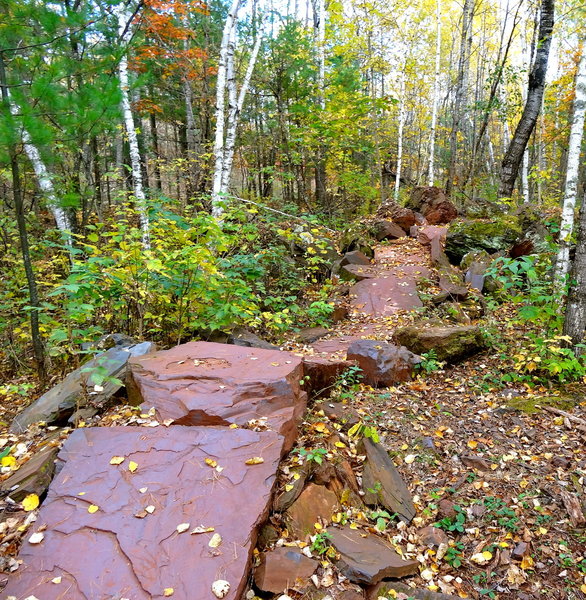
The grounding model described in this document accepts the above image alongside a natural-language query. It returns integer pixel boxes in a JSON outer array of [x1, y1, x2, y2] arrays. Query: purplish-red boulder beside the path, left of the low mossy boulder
[[347, 340, 421, 387]]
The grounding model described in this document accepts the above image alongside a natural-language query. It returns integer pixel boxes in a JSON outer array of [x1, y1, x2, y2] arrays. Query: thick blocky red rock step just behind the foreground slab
[[128, 342, 307, 449]]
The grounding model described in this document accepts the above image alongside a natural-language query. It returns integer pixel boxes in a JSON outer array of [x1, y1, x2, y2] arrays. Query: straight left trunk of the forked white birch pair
[[212, 0, 240, 218]]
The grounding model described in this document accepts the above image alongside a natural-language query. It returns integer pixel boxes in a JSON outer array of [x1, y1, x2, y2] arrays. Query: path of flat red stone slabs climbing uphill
[[4, 227, 438, 600]]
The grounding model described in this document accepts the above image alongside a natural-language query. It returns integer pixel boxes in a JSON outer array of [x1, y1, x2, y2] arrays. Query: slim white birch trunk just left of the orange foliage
[[116, 4, 150, 249]]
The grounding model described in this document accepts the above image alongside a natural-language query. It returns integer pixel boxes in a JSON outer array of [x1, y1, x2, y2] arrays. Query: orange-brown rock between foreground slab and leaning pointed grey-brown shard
[[286, 484, 338, 539]]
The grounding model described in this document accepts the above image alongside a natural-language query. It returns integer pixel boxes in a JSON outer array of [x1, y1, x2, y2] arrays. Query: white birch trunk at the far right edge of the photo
[[556, 40, 586, 282]]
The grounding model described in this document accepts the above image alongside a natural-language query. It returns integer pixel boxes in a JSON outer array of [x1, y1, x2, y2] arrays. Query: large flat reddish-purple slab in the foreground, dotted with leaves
[[2, 426, 282, 600]]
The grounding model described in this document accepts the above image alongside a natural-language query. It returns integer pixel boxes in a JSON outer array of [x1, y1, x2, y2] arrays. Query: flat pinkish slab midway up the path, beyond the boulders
[[350, 265, 429, 316]]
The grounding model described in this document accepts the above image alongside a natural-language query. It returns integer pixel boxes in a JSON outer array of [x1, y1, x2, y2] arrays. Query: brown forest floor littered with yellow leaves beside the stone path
[[0, 240, 586, 600]]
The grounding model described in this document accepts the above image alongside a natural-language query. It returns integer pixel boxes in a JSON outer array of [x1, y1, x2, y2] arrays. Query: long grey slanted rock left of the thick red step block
[[10, 342, 155, 433]]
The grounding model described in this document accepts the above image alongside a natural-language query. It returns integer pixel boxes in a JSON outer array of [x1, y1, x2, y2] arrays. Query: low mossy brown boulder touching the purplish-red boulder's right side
[[394, 325, 486, 364]]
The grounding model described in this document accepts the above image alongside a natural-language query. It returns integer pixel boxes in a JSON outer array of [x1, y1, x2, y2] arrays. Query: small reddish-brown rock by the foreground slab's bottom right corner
[[254, 546, 319, 594]]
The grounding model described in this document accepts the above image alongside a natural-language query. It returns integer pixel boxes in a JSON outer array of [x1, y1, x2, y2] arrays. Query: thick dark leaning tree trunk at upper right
[[499, 0, 554, 198]]
